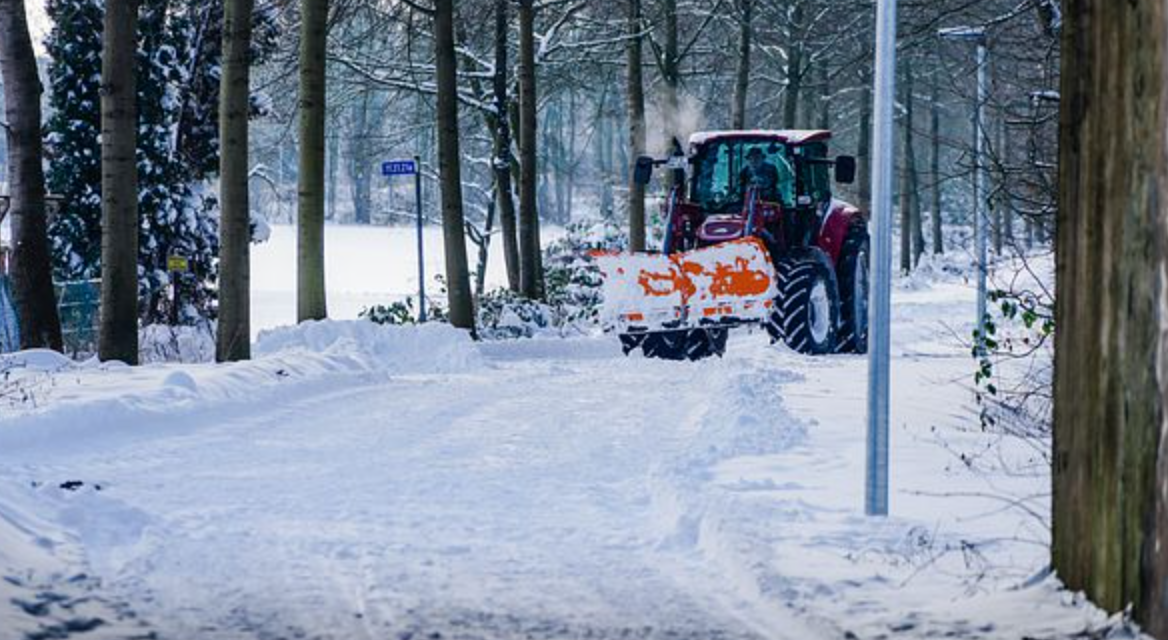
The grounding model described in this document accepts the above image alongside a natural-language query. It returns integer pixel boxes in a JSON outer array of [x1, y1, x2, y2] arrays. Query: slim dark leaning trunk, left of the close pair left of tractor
[[491, 0, 520, 291]]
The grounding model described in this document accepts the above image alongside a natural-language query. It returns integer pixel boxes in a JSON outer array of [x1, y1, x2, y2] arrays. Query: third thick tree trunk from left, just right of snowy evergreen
[[215, 0, 253, 362]]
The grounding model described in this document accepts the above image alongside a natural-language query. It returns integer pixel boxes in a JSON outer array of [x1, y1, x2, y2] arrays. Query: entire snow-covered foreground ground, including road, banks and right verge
[[0, 248, 1130, 640]]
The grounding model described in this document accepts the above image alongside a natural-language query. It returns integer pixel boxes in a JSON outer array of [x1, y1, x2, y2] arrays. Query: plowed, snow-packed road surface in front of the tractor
[[4, 341, 826, 639]]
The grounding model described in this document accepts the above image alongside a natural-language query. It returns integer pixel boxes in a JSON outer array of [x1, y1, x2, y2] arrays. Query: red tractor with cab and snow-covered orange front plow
[[600, 131, 869, 360]]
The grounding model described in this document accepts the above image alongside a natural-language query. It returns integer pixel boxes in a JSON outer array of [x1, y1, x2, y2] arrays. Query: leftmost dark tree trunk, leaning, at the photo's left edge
[[0, 0, 62, 352]]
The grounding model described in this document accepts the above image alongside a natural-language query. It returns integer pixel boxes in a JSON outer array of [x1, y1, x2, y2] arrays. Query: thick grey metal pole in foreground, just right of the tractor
[[864, 0, 896, 516]]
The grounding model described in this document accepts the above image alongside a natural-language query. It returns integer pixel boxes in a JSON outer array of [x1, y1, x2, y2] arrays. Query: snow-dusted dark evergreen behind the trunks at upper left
[[46, 0, 277, 325]]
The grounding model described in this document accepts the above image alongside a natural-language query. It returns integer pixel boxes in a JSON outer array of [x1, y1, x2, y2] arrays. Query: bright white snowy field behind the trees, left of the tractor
[[251, 224, 564, 334]]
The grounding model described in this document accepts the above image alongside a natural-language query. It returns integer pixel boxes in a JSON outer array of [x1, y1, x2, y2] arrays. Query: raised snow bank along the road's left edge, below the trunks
[[0, 320, 481, 459]]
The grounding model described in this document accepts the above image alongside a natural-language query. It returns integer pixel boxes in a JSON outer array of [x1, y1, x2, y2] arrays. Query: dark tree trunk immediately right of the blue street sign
[[433, 0, 474, 333]]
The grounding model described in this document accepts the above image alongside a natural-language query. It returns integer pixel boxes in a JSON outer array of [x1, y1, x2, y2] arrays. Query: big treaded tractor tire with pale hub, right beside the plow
[[766, 250, 840, 355]]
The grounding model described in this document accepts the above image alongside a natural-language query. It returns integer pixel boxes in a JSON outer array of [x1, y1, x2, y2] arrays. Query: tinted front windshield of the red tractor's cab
[[693, 138, 795, 213]]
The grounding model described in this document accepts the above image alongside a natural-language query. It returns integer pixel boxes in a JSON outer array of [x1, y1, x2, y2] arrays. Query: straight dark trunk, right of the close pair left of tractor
[[519, 0, 543, 299]]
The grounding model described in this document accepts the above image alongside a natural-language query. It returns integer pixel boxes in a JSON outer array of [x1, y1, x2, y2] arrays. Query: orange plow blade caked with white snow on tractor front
[[597, 238, 778, 333]]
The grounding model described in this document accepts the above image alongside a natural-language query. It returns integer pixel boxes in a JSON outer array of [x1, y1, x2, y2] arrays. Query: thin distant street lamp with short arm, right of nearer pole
[[937, 27, 989, 354]]
